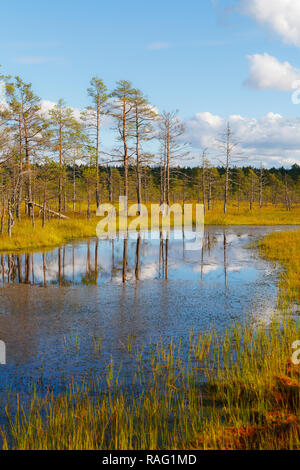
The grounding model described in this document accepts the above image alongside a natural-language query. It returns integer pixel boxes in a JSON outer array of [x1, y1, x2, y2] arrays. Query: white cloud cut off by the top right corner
[[240, 0, 300, 47]]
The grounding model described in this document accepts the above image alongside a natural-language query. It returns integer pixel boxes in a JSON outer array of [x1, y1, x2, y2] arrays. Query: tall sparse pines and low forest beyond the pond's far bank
[[0, 69, 300, 235]]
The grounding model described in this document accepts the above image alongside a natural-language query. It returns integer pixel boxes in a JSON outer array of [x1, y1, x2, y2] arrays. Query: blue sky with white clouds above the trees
[[0, 0, 300, 167]]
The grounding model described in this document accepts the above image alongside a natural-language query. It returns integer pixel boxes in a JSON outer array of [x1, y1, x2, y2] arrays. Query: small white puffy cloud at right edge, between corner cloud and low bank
[[245, 53, 300, 91]]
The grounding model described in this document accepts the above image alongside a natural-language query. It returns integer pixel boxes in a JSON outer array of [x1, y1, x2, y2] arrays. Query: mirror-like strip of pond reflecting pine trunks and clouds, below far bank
[[0, 227, 290, 288]]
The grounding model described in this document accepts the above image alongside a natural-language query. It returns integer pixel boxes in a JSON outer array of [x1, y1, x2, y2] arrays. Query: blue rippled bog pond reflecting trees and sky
[[0, 226, 292, 402]]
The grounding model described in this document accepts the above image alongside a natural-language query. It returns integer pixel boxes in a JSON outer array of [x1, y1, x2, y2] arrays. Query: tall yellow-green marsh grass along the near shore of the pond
[[0, 320, 300, 450]]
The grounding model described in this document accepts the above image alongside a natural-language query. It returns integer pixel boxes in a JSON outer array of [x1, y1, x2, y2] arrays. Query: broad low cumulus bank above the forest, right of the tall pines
[[185, 112, 300, 166]]
